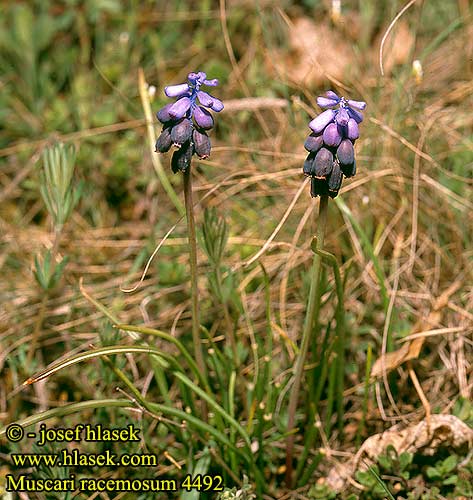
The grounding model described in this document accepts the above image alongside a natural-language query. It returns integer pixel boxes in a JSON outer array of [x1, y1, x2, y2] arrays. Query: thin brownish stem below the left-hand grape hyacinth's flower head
[[184, 168, 207, 392]]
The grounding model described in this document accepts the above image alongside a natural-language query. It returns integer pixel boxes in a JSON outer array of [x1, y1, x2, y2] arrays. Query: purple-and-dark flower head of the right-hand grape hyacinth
[[303, 91, 366, 198]]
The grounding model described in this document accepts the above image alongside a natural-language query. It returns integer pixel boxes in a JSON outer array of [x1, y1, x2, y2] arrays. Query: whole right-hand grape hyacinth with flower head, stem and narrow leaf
[[286, 91, 366, 486]]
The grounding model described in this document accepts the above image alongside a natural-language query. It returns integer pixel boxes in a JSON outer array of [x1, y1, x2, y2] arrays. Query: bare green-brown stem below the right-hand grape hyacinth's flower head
[[286, 195, 328, 487]]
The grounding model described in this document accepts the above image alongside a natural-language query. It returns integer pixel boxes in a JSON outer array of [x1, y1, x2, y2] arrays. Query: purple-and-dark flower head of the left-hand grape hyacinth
[[156, 71, 223, 173]]
